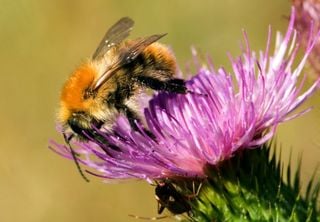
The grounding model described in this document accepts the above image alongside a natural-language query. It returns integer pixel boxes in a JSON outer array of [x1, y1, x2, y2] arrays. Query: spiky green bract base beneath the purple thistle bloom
[[172, 145, 320, 222]]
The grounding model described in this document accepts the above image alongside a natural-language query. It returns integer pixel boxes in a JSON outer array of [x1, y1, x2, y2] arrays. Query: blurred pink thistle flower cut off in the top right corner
[[292, 0, 320, 74]]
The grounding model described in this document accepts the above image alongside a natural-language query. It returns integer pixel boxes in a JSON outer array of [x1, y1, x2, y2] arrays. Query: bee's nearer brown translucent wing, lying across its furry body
[[93, 34, 166, 90]]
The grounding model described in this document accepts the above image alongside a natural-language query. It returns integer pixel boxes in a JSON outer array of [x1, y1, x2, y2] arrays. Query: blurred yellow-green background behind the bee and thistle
[[0, 0, 320, 222]]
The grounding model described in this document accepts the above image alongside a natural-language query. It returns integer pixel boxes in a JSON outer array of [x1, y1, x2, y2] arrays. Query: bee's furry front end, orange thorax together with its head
[[58, 61, 115, 139]]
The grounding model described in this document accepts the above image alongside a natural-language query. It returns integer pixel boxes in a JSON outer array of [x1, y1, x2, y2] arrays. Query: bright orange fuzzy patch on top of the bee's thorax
[[58, 62, 98, 123]]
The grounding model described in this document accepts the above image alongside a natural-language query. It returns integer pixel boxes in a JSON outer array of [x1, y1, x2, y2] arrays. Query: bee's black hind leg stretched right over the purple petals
[[137, 76, 188, 94]]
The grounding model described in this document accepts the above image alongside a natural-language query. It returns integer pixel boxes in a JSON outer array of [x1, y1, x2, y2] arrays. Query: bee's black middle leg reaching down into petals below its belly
[[115, 103, 156, 139]]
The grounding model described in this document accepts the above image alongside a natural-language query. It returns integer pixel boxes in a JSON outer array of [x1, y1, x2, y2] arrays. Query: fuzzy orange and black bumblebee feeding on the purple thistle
[[58, 17, 188, 180]]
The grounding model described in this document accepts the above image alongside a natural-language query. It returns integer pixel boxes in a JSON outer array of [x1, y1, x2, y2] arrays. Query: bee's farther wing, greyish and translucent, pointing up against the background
[[92, 17, 134, 60]]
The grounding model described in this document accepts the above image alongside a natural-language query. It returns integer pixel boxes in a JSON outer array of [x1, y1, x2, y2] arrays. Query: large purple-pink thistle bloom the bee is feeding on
[[51, 10, 318, 180]]
